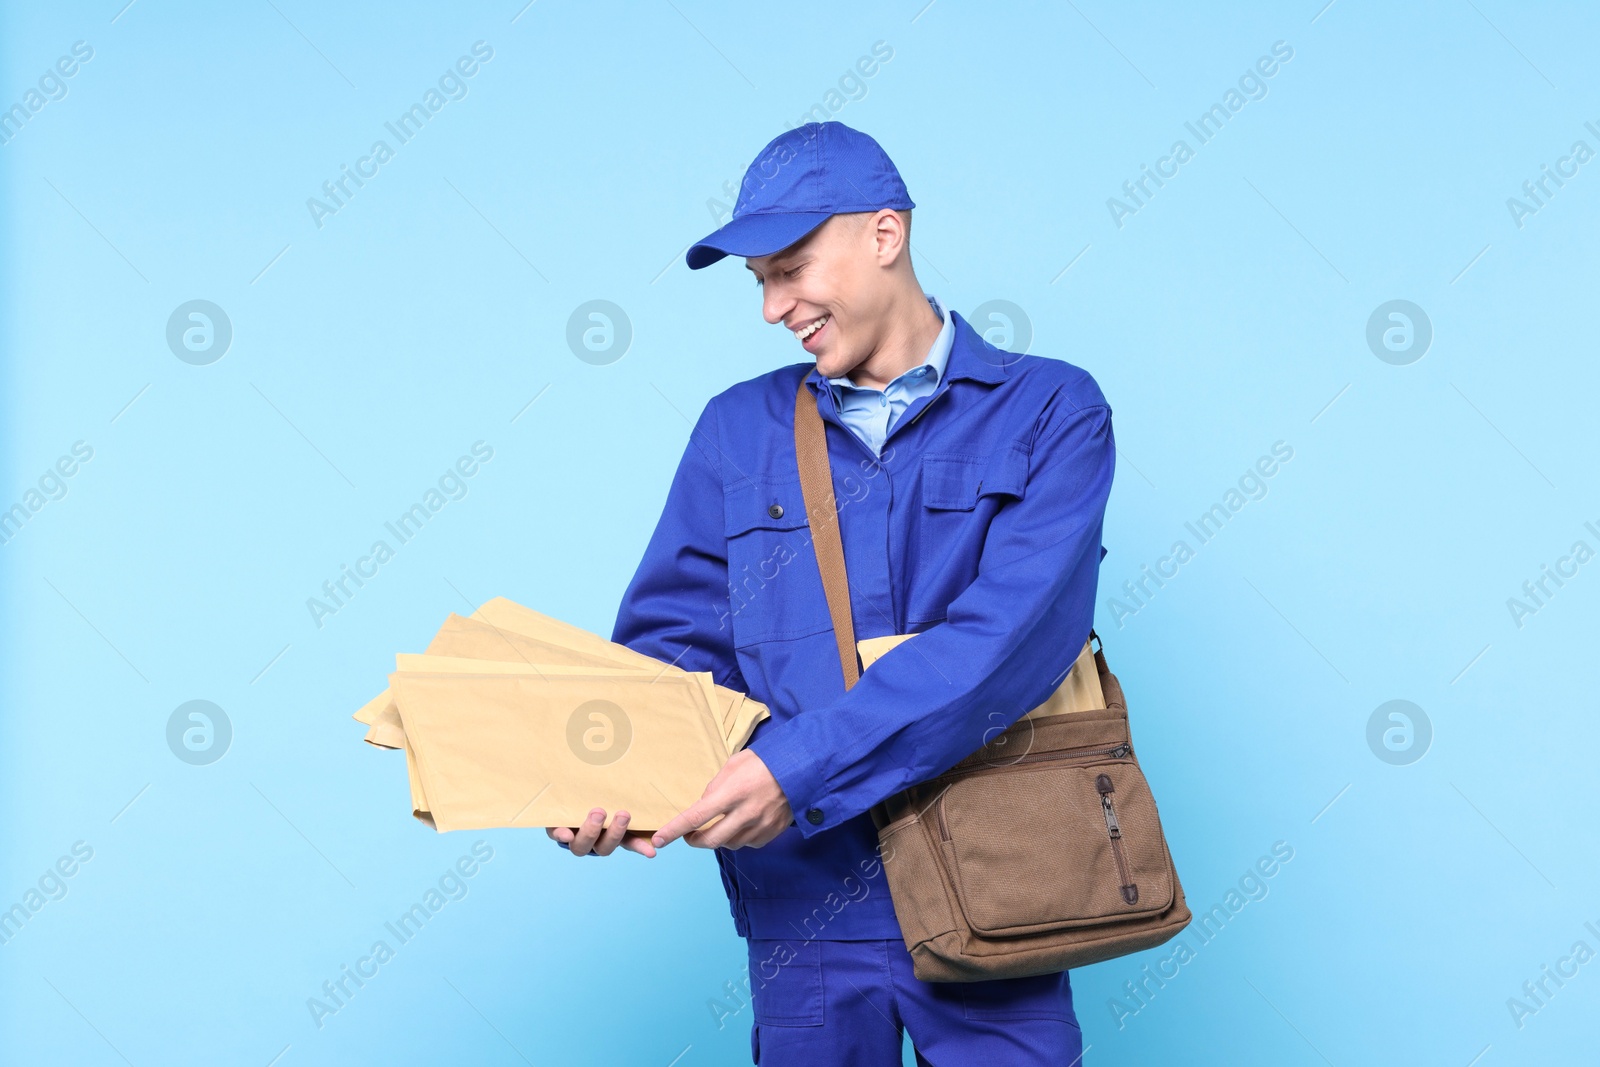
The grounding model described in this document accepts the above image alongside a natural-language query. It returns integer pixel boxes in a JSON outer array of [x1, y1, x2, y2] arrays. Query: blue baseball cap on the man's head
[[683, 122, 917, 270]]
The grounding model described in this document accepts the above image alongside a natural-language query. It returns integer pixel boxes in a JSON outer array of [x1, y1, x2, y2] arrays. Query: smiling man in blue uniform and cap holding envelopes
[[550, 122, 1114, 1067]]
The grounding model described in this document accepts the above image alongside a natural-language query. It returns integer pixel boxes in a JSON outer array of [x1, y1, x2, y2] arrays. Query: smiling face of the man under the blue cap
[[744, 213, 891, 378]]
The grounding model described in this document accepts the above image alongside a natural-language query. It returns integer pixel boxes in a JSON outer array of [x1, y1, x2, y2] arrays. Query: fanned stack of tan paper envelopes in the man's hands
[[355, 597, 768, 832]]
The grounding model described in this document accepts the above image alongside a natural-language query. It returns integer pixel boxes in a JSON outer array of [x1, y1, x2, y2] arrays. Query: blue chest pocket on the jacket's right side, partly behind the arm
[[907, 445, 1029, 627]]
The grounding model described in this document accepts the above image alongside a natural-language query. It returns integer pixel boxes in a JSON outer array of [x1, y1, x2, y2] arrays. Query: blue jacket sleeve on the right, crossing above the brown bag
[[750, 389, 1115, 837]]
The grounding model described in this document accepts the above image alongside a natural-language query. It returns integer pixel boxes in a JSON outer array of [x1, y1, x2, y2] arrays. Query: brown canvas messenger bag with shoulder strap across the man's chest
[[795, 381, 1189, 982]]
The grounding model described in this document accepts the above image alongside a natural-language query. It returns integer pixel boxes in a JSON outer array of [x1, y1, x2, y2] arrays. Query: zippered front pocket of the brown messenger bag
[[934, 745, 1173, 937]]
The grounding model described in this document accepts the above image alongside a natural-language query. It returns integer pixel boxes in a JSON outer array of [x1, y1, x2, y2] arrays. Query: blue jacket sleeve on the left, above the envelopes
[[611, 402, 747, 693]]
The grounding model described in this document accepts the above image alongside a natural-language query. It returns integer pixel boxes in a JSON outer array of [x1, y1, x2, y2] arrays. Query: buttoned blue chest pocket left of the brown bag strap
[[722, 478, 832, 646]]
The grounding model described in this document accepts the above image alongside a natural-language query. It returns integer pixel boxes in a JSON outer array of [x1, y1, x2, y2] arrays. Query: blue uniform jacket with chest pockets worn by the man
[[611, 312, 1115, 941]]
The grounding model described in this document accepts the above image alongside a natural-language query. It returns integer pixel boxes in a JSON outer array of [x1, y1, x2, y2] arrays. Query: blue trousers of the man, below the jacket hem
[[747, 939, 1083, 1067]]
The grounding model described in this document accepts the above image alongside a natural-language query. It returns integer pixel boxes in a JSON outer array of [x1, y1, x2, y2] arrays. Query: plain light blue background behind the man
[[0, 0, 1600, 1067]]
